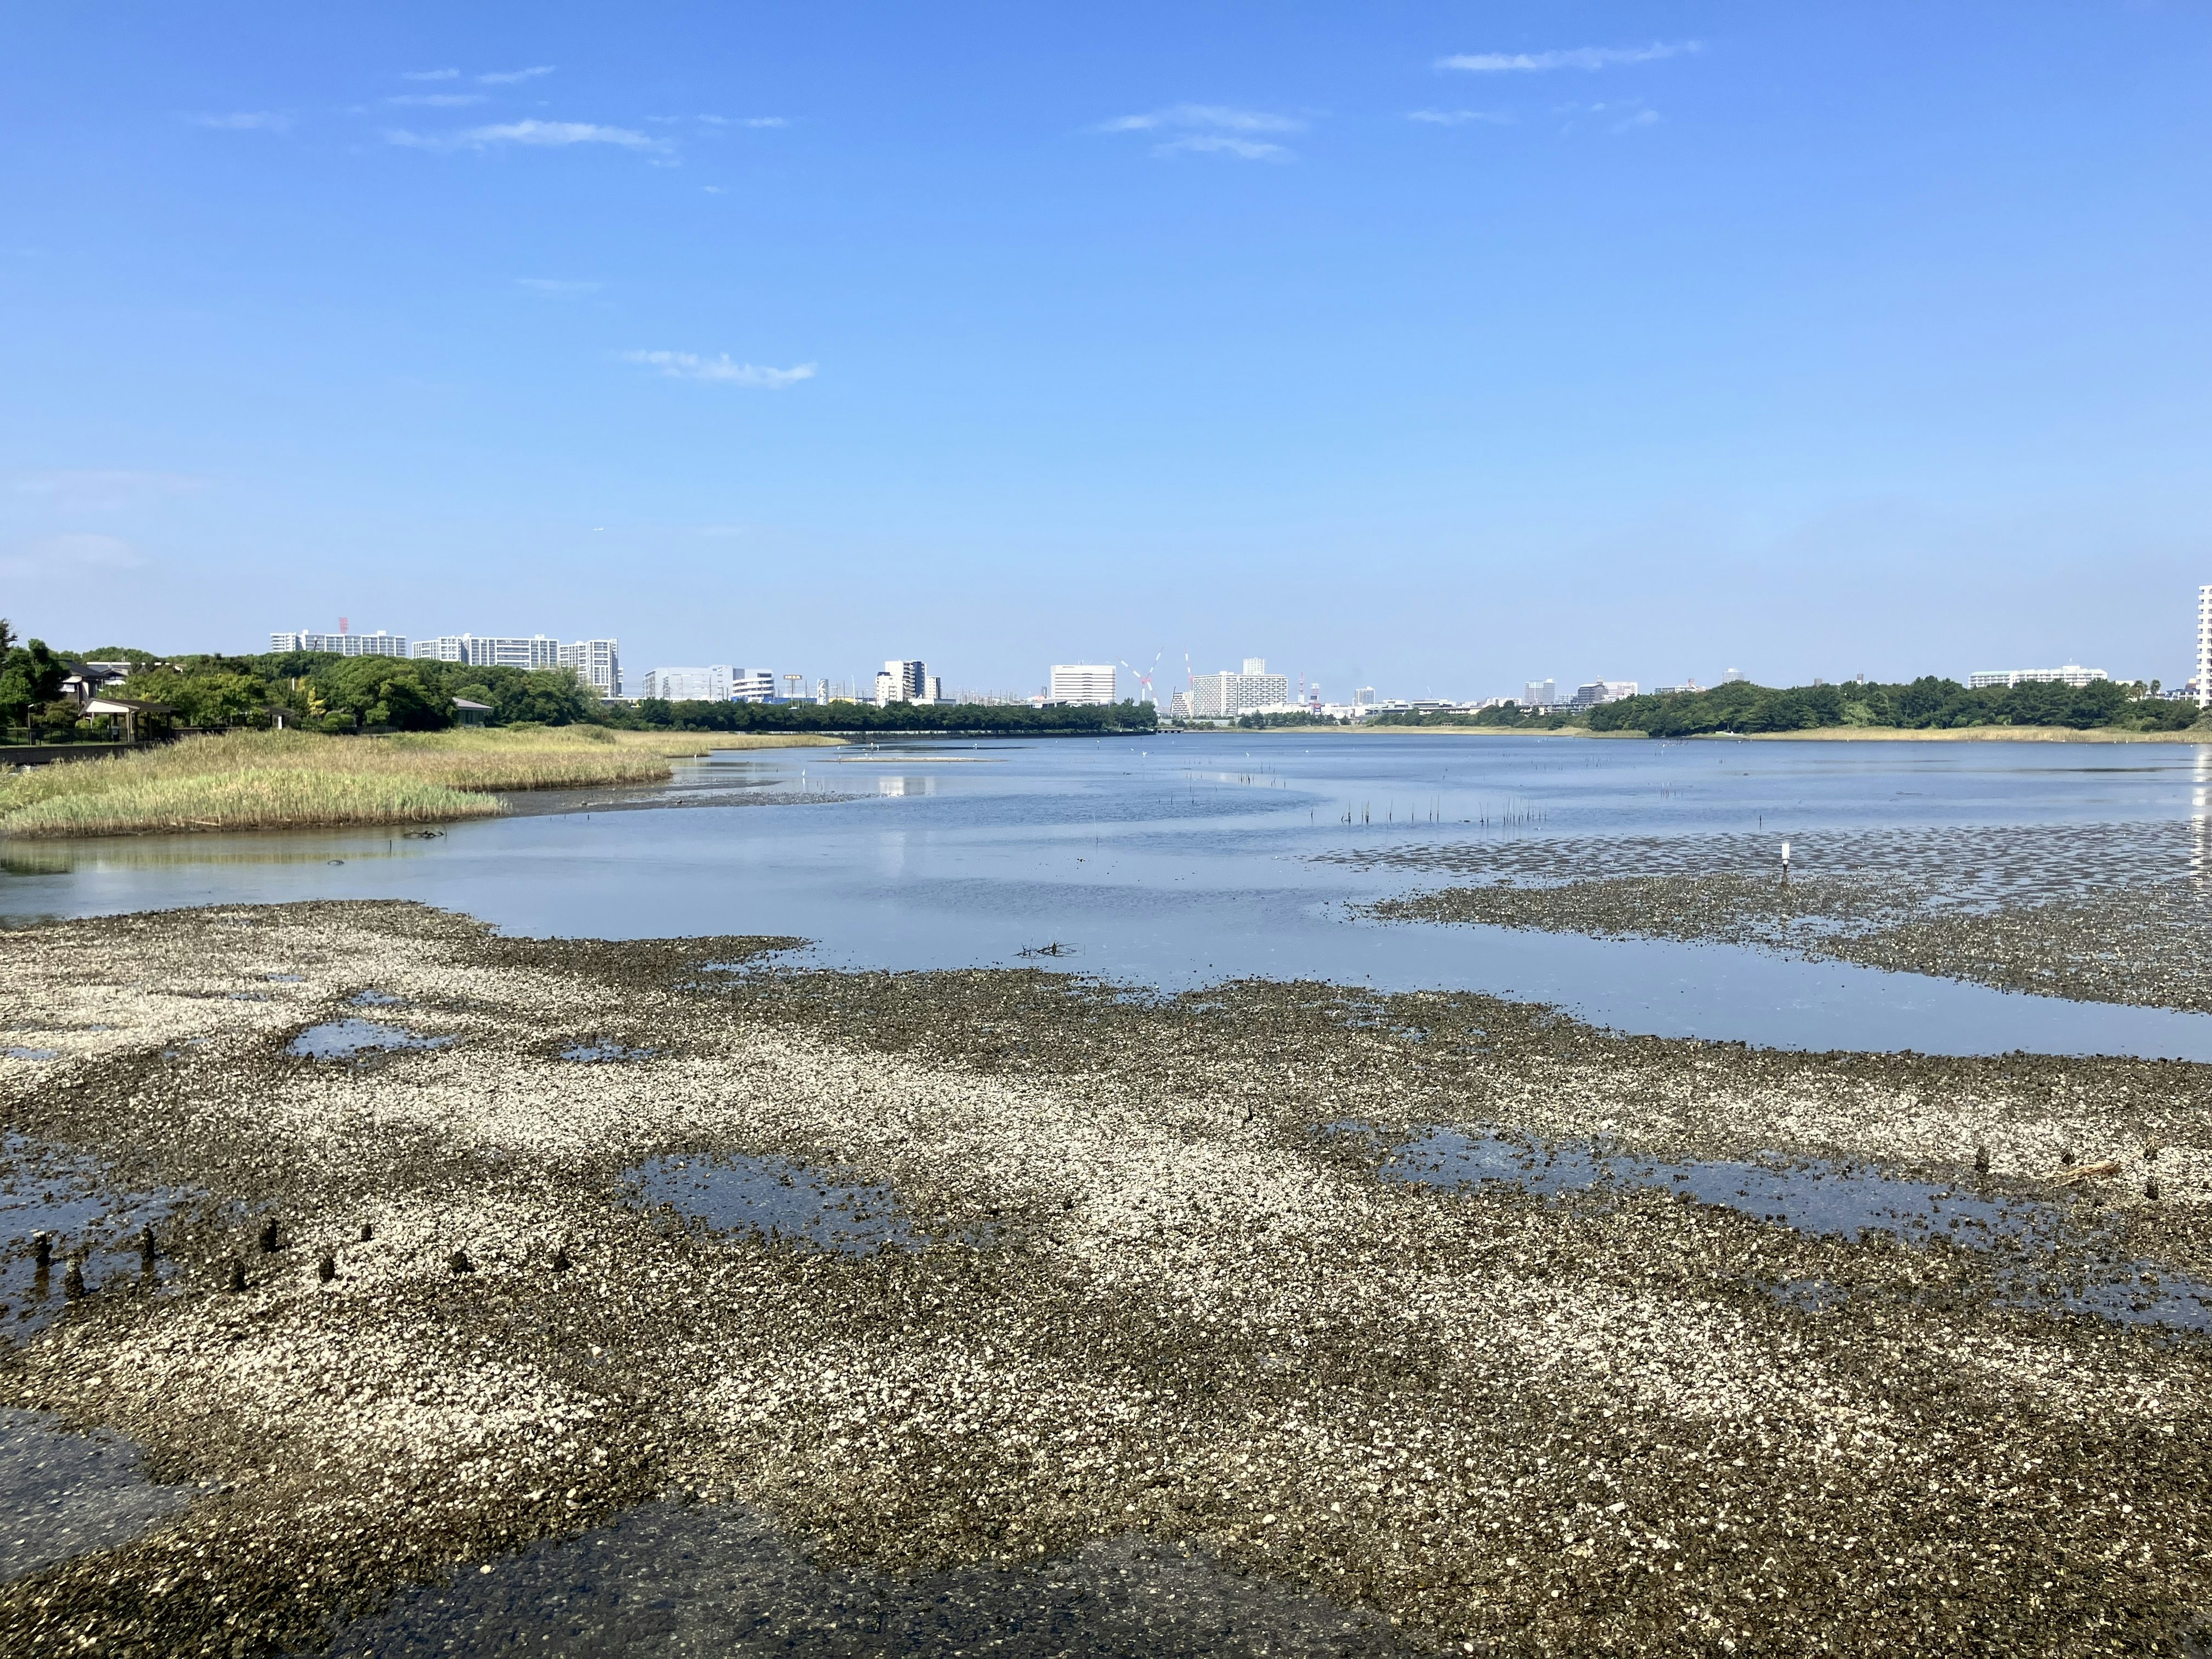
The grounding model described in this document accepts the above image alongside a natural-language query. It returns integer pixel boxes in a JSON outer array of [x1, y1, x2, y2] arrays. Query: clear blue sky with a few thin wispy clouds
[[0, 0, 2212, 695]]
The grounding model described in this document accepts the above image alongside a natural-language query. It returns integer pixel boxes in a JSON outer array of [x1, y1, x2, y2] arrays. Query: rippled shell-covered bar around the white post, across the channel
[[1327, 823, 2212, 1013]]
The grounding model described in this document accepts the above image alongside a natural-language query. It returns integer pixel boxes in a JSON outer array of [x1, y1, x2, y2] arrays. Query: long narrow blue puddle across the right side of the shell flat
[[1371, 1124, 2212, 1332]]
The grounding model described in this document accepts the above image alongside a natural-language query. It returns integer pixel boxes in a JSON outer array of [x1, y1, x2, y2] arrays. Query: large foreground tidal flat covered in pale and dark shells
[[0, 903, 2212, 1654]]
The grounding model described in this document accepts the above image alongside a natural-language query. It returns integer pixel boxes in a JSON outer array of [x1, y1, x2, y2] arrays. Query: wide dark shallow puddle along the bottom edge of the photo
[[329, 1502, 1407, 1659]]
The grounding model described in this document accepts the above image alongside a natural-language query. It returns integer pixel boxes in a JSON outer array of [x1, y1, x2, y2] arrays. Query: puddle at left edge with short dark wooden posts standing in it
[[0, 1135, 190, 1336]]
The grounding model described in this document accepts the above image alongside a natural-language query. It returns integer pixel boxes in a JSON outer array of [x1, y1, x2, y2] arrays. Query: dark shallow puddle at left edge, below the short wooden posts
[[0, 1407, 192, 1584]]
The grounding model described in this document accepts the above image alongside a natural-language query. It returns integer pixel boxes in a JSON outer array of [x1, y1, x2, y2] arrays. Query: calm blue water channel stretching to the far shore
[[0, 732, 2212, 1059]]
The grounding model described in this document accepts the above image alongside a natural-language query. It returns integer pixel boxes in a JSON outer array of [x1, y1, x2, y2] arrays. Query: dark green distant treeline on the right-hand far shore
[[1378, 675, 2199, 737]]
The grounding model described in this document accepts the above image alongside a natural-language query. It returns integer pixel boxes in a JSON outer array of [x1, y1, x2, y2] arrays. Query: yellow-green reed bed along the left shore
[[0, 726, 836, 838]]
